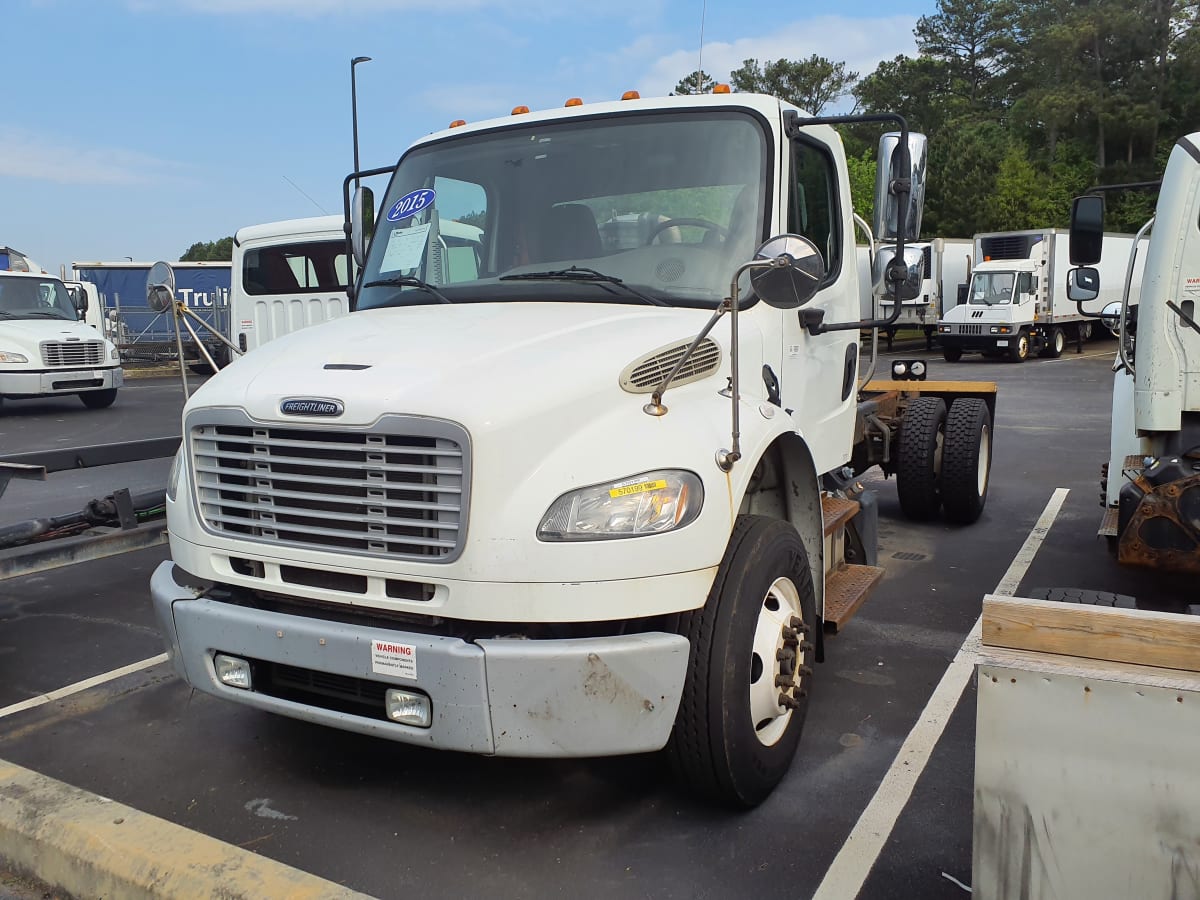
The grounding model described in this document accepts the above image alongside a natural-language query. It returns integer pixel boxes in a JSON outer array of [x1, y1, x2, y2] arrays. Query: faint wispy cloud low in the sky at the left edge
[[0, 126, 176, 185]]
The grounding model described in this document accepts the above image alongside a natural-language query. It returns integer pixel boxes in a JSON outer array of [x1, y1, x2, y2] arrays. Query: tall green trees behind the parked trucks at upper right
[[677, 0, 1200, 238]]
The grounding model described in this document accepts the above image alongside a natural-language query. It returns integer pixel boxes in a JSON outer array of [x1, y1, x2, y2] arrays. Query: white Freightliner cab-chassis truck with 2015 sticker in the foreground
[[150, 94, 995, 806]]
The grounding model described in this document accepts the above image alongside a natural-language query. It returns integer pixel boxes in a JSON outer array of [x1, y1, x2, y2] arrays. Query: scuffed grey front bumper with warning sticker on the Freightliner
[[150, 562, 689, 757]]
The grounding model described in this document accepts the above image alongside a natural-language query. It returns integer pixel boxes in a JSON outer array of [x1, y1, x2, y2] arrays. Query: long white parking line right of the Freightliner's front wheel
[[812, 487, 1068, 900]]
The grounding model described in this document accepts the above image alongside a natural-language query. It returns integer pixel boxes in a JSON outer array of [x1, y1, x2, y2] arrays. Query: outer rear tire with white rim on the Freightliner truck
[[942, 397, 991, 524]]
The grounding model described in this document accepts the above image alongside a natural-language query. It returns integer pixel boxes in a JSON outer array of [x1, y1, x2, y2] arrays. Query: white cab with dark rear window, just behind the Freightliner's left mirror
[[229, 216, 349, 350]]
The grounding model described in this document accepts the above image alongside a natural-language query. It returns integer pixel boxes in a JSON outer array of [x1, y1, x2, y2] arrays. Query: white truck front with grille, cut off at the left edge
[[0, 271, 124, 409]]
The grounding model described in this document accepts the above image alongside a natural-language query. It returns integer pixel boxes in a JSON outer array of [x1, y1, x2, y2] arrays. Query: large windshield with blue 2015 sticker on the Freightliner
[[358, 112, 767, 310]]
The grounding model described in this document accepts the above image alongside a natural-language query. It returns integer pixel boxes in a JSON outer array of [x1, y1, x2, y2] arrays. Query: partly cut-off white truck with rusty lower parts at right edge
[[1070, 132, 1200, 574]]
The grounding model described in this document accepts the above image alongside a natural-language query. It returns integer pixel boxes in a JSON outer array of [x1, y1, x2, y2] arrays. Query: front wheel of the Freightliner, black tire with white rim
[[666, 516, 817, 809]]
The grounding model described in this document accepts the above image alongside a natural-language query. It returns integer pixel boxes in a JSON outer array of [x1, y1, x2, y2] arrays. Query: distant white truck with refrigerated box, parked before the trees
[[937, 228, 1140, 362]]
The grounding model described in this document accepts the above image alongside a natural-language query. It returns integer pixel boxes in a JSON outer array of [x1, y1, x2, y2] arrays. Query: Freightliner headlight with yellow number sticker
[[538, 469, 704, 541]]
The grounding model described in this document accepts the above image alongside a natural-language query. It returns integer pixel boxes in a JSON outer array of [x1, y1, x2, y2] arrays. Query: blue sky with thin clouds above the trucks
[[0, 0, 936, 274]]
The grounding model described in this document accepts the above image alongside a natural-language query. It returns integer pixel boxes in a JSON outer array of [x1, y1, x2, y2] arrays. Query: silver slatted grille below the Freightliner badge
[[188, 410, 469, 562]]
